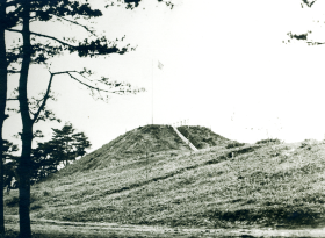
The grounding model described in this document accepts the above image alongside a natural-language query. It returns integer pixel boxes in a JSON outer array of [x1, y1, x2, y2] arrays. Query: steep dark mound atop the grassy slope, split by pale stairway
[[55, 124, 229, 173]]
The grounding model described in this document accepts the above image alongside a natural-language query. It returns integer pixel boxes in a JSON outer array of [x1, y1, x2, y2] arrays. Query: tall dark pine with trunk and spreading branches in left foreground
[[0, 0, 173, 238]]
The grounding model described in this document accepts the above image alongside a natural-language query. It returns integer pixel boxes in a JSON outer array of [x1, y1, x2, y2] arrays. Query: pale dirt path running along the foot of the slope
[[6, 216, 325, 238]]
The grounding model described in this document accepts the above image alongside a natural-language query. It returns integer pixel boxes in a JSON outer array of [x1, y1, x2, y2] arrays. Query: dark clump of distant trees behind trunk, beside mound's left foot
[[2, 123, 91, 186]]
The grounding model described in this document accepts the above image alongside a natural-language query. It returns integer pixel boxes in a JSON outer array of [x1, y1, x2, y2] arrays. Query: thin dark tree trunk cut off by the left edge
[[0, 0, 7, 237]]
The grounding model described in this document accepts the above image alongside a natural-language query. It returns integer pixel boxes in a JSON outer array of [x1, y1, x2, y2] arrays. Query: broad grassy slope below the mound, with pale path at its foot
[[4, 143, 325, 238]]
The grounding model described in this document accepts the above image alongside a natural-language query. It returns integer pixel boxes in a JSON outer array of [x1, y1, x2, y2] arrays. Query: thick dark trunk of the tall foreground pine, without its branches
[[18, 1, 33, 238]]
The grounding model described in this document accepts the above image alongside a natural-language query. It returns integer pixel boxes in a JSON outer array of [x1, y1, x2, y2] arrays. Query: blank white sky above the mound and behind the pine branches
[[4, 0, 325, 150]]
